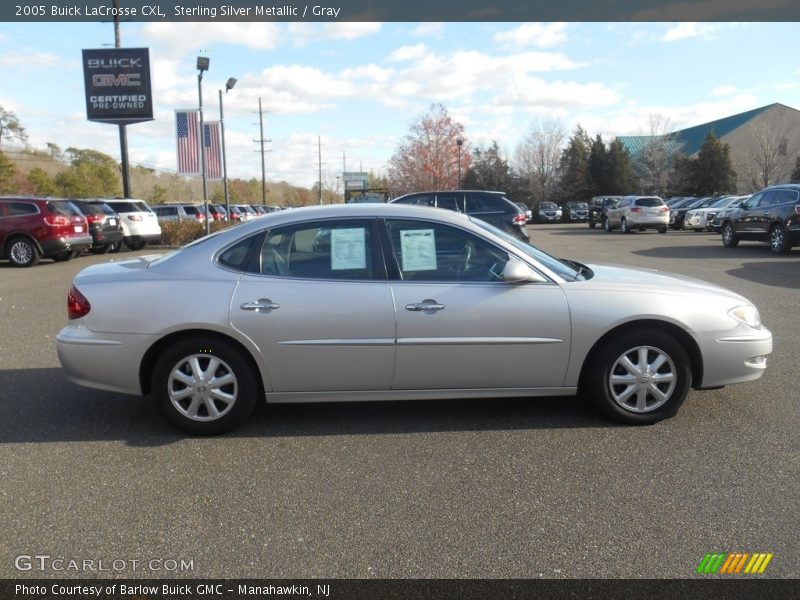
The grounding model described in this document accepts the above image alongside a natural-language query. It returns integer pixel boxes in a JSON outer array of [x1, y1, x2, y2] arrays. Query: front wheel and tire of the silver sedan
[[585, 329, 692, 425]]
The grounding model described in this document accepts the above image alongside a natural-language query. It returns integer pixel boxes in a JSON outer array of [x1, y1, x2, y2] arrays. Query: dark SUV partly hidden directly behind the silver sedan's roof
[[391, 190, 530, 242]]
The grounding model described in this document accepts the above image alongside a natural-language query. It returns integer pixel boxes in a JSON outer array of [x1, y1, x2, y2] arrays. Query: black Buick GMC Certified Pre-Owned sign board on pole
[[83, 48, 153, 125]]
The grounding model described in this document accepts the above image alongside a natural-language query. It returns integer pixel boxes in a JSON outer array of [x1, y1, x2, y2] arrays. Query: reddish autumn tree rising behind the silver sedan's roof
[[388, 104, 472, 194]]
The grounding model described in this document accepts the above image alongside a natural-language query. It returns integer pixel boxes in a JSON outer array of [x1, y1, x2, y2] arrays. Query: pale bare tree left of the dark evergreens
[[515, 119, 566, 202]]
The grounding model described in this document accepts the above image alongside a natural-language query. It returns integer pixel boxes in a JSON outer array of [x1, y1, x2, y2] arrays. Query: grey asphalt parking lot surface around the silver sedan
[[0, 224, 800, 578]]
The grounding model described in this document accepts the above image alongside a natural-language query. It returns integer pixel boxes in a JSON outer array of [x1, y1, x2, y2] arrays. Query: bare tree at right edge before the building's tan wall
[[734, 112, 800, 192]]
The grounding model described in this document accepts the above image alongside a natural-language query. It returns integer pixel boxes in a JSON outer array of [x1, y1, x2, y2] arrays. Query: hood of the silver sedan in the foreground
[[582, 264, 749, 304]]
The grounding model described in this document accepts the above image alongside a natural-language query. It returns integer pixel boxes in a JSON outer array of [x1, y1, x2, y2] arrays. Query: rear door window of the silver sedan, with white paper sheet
[[257, 220, 383, 280]]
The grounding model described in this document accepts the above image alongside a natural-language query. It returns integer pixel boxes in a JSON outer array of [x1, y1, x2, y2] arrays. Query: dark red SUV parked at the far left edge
[[0, 196, 92, 267]]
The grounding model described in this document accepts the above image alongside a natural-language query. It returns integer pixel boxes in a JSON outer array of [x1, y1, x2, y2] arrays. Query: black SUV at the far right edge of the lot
[[722, 184, 800, 254]]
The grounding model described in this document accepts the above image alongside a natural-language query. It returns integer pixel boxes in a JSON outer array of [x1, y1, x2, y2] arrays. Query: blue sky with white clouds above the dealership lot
[[0, 22, 800, 186]]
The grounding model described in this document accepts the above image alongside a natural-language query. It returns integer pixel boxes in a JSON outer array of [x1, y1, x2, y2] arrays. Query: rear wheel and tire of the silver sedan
[[151, 338, 261, 435]]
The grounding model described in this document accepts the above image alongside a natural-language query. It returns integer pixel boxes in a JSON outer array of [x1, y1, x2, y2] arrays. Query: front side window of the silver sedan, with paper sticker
[[386, 221, 508, 281]]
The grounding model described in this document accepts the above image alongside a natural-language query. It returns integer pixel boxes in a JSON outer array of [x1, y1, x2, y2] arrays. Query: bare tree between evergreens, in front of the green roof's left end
[[633, 113, 679, 195]]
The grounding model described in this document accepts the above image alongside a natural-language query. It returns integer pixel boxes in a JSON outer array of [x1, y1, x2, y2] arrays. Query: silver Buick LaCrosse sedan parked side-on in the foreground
[[57, 204, 772, 434]]
